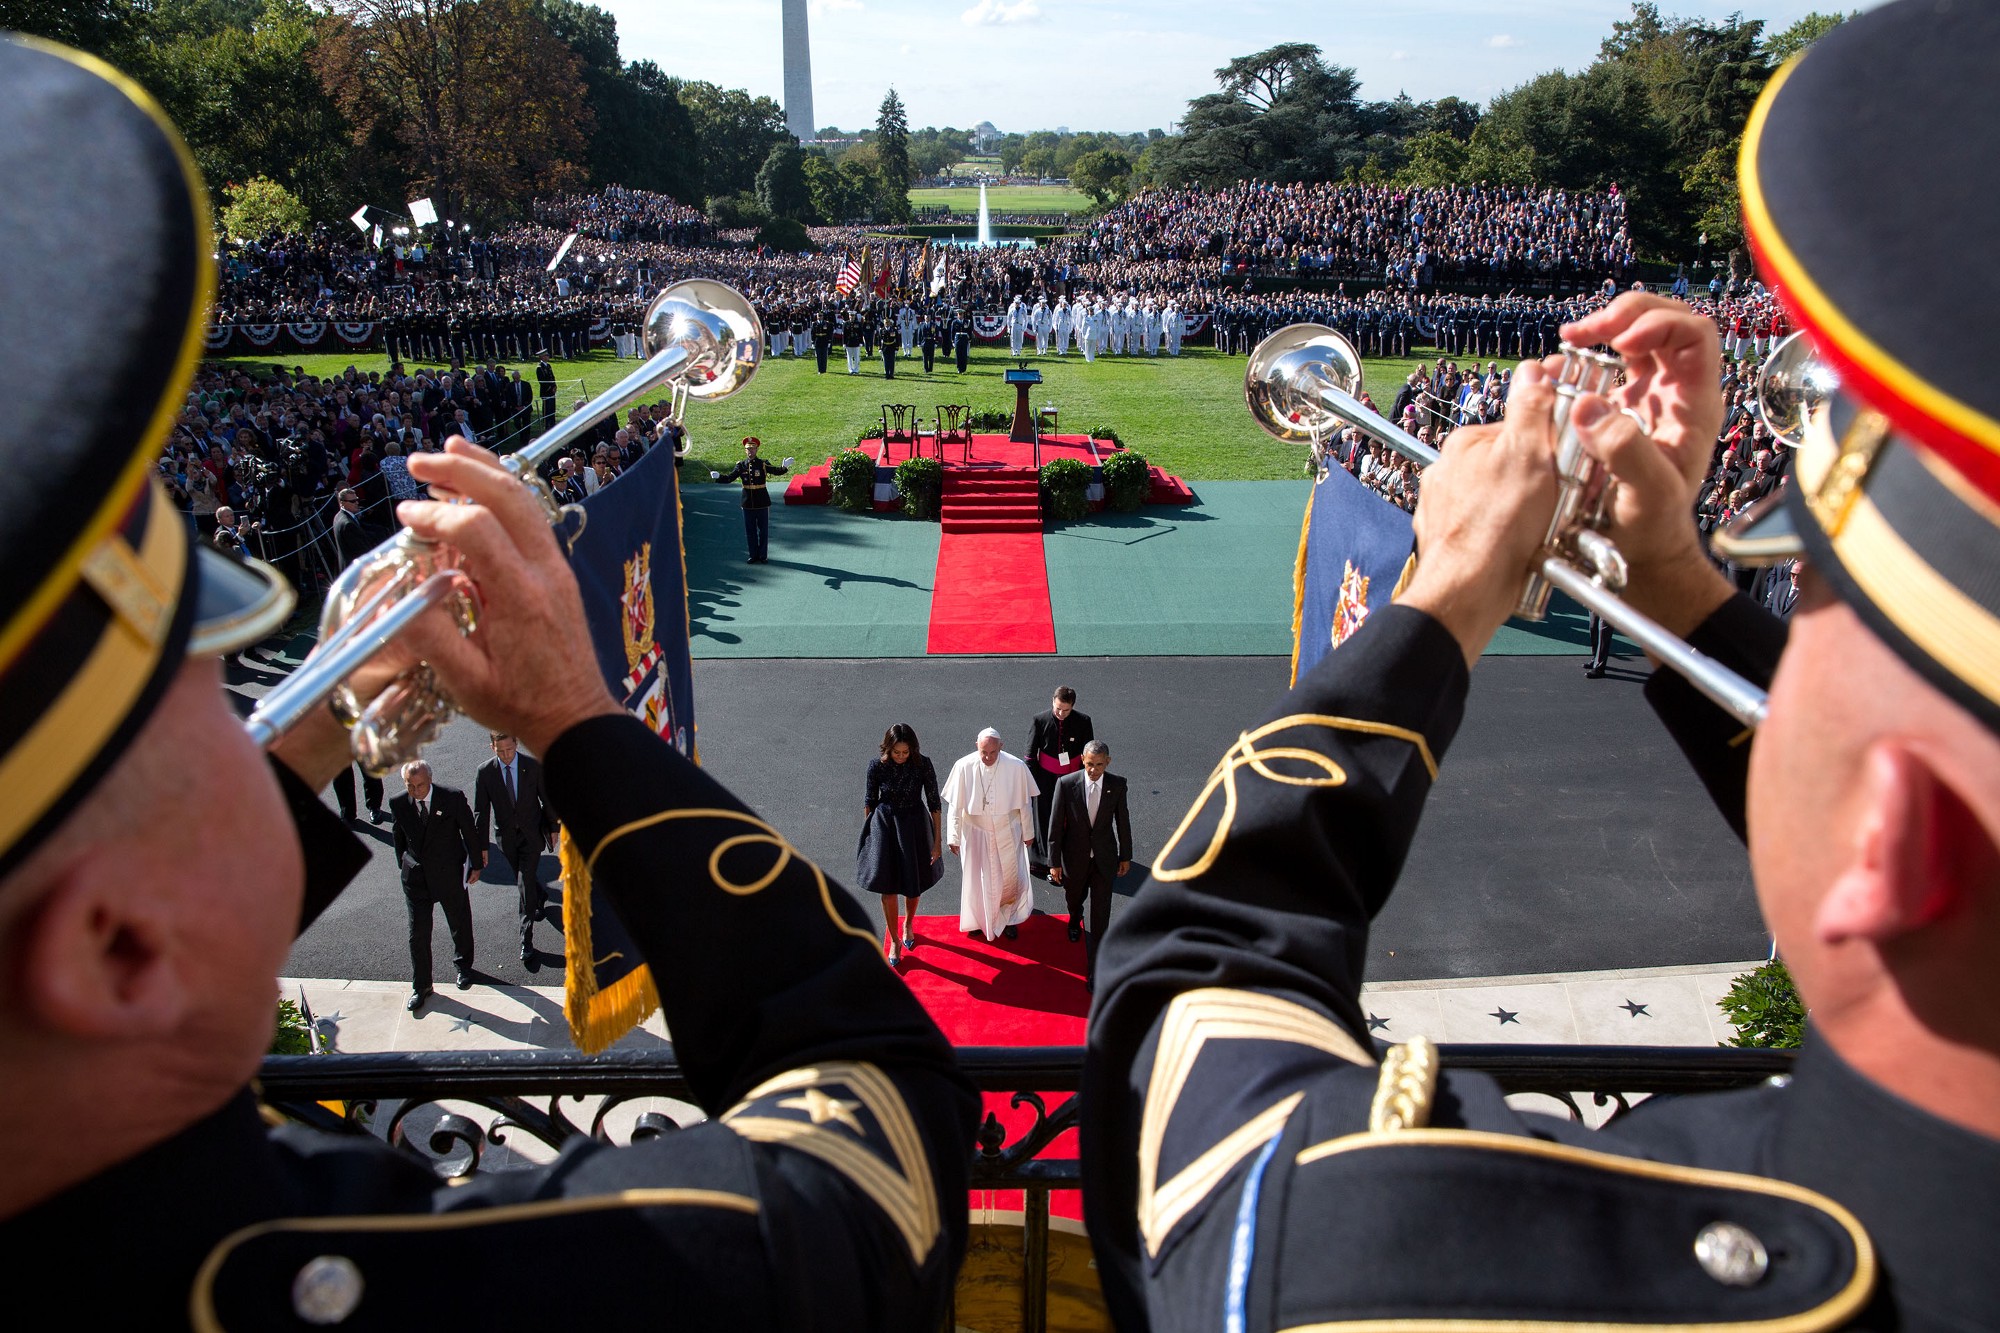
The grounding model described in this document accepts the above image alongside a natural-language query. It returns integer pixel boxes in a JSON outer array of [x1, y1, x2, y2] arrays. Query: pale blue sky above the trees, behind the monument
[[594, 0, 1878, 130]]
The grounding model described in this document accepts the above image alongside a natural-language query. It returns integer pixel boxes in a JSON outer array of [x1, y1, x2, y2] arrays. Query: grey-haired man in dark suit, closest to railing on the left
[[388, 759, 486, 1013]]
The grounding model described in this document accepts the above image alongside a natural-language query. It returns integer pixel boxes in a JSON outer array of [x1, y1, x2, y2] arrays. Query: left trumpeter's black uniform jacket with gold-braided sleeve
[[0, 717, 978, 1331]]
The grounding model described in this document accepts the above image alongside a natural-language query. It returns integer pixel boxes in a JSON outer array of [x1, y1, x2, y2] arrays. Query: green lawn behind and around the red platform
[[226, 344, 1464, 480]]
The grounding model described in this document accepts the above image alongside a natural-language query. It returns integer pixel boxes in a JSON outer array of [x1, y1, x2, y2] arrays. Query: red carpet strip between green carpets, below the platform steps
[[924, 522, 1056, 652]]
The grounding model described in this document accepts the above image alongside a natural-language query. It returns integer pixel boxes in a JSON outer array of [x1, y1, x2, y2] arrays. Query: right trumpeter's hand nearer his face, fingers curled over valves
[[1564, 292, 1734, 636]]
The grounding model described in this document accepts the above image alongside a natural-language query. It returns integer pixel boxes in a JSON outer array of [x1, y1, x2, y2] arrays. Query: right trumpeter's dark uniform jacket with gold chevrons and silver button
[[1080, 598, 2000, 1333]]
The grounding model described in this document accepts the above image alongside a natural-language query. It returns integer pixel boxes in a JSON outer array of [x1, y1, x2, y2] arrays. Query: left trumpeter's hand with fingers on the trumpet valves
[[396, 436, 618, 755]]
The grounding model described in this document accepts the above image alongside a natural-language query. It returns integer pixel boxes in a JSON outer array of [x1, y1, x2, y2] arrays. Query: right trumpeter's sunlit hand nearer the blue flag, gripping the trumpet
[[1396, 362, 1556, 667]]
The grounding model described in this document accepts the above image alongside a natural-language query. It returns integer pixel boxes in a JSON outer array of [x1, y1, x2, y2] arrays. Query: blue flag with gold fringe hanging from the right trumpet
[[1292, 464, 1416, 685]]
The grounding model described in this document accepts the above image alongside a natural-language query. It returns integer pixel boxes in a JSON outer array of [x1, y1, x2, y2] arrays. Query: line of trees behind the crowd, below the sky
[[0, 0, 1840, 256]]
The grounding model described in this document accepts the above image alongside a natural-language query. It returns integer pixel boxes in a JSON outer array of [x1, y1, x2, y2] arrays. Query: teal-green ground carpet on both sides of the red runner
[[682, 478, 1634, 656]]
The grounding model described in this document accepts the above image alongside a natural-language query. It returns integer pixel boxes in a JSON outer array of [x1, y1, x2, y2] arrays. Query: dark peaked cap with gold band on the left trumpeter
[[0, 34, 292, 873]]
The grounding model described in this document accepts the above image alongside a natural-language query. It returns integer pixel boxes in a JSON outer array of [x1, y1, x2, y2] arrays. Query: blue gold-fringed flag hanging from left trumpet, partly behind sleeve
[[562, 448, 698, 1051]]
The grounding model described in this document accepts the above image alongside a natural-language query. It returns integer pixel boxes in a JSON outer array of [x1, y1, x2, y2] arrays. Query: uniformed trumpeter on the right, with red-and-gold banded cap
[[1082, 4, 2000, 1329]]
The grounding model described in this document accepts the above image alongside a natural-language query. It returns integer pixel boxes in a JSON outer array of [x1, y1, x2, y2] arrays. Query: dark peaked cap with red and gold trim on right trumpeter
[[1714, 0, 2000, 731]]
